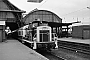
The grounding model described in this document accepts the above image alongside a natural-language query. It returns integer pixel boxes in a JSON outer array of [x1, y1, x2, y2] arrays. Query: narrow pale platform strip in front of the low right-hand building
[[58, 37, 90, 44]]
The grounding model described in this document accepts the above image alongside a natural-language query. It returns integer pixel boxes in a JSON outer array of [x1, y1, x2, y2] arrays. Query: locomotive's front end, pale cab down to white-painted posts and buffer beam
[[33, 26, 58, 49]]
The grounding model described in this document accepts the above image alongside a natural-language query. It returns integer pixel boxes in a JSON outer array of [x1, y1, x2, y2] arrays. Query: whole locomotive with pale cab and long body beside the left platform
[[18, 21, 58, 49]]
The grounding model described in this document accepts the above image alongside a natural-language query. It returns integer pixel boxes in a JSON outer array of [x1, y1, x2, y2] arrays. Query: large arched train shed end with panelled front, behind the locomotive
[[22, 8, 62, 24]]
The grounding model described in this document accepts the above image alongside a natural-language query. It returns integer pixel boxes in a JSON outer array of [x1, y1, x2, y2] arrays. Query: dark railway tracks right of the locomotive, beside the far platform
[[58, 40, 90, 55]]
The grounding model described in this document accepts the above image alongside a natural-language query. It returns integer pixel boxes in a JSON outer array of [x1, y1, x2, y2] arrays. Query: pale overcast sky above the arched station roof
[[9, 0, 90, 25]]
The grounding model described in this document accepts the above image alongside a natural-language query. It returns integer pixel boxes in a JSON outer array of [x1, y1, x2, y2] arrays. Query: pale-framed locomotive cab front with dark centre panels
[[37, 26, 52, 42]]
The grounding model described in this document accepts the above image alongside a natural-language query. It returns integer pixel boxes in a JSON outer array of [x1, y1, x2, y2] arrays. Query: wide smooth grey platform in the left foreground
[[0, 39, 49, 60]]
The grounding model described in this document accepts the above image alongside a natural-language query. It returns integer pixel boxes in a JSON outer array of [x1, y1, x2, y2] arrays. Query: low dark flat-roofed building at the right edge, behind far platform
[[72, 25, 90, 39]]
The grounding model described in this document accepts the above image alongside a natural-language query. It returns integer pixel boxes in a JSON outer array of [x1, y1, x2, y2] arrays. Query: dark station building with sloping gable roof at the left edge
[[0, 0, 25, 41]]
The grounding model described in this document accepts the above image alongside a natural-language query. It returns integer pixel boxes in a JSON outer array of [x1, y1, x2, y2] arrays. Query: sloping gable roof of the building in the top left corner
[[0, 0, 25, 13]]
